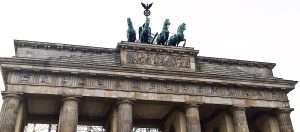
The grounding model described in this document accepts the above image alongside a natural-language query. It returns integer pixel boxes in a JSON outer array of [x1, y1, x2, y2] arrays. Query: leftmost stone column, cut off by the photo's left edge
[[0, 94, 22, 132]]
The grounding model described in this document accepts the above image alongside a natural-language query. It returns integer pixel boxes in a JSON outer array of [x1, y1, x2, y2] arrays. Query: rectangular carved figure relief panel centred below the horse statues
[[126, 52, 191, 68]]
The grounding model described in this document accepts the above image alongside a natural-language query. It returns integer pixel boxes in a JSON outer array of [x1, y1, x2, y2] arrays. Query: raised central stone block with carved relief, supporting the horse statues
[[118, 42, 198, 71]]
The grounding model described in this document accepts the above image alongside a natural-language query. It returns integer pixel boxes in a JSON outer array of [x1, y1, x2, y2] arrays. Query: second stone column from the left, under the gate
[[58, 97, 78, 132]]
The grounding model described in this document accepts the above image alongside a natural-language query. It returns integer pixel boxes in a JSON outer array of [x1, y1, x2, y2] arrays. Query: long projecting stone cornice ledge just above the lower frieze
[[1, 64, 296, 92]]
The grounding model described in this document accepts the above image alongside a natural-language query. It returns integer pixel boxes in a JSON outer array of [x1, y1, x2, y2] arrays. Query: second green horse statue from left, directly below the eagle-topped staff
[[139, 18, 152, 44]]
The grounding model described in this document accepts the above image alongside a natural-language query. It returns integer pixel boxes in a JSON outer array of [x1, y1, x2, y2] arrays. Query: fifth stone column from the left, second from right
[[231, 107, 249, 132]]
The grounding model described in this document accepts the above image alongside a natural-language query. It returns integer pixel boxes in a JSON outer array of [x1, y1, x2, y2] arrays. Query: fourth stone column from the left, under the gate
[[185, 103, 201, 132]]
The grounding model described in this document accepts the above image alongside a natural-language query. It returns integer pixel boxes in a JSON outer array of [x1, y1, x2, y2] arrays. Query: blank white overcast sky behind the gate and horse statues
[[0, 0, 300, 131]]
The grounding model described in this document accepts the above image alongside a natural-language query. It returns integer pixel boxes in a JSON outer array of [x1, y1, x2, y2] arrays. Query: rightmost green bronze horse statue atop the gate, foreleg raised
[[168, 23, 186, 47]]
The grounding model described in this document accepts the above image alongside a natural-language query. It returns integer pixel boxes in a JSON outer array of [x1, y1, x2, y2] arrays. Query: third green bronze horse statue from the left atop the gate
[[156, 19, 171, 45]]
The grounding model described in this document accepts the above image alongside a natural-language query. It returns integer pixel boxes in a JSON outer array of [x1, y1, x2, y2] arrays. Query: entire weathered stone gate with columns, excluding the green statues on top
[[0, 40, 297, 132]]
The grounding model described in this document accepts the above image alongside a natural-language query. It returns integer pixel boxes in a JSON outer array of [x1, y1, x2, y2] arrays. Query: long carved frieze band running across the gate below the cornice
[[8, 73, 288, 101]]
